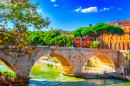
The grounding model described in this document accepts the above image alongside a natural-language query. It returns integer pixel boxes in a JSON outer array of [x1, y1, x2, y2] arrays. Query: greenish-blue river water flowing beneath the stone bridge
[[0, 60, 130, 86]]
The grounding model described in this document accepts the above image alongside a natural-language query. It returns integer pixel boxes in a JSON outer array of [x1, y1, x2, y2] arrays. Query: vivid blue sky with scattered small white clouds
[[31, 0, 130, 31]]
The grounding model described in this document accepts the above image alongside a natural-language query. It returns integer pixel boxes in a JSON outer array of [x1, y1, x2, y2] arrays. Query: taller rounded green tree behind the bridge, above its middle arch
[[43, 30, 61, 45]]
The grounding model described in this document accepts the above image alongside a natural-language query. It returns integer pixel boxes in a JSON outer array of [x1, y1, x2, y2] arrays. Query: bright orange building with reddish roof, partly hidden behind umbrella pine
[[101, 20, 130, 50]]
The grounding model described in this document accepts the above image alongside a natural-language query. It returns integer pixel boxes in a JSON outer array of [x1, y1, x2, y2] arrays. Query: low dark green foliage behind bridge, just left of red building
[[53, 36, 73, 47]]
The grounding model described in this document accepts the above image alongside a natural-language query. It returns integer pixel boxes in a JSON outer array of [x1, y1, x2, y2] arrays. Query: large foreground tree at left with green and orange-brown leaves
[[0, 0, 50, 57]]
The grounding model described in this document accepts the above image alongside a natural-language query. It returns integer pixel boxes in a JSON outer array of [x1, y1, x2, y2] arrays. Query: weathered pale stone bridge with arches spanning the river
[[0, 46, 129, 78]]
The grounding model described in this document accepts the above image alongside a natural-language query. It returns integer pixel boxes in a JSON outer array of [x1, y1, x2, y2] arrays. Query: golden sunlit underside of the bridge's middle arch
[[30, 53, 74, 76]]
